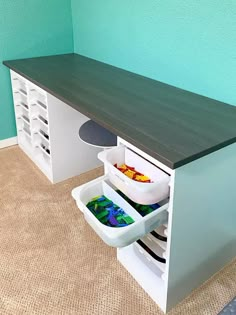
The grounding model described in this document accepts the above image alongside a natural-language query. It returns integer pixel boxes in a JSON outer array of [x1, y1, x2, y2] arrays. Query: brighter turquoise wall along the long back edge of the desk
[[72, 0, 236, 105]]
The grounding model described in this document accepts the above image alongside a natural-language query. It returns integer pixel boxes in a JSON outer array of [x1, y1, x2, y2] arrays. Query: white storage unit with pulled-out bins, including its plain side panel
[[72, 138, 236, 312]]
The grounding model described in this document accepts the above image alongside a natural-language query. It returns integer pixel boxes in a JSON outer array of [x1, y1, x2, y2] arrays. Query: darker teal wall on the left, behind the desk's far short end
[[0, 0, 73, 140]]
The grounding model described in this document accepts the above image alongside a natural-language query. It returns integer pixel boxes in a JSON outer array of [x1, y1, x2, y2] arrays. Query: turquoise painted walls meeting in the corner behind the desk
[[0, 0, 236, 140]]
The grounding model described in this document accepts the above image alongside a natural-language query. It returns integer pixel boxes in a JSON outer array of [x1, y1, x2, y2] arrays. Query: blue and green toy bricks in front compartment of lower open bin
[[87, 195, 134, 227]]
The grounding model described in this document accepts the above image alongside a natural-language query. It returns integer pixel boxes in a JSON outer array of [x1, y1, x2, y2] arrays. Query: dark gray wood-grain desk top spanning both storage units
[[4, 54, 236, 169]]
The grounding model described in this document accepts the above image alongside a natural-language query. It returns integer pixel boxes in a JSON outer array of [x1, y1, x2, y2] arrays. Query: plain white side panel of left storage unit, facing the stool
[[47, 93, 102, 183]]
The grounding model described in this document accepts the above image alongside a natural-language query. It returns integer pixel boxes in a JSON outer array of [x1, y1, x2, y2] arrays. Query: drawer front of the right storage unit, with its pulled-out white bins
[[72, 138, 173, 310]]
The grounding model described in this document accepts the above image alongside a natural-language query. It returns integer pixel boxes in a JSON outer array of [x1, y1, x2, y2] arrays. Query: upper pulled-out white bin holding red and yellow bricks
[[98, 145, 170, 205]]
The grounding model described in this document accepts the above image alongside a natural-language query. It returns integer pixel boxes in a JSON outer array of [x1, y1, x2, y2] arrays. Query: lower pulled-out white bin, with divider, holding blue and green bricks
[[72, 176, 169, 247]]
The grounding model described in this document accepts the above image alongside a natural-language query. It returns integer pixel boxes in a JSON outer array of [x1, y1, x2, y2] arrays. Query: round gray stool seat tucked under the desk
[[79, 120, 117, 148]]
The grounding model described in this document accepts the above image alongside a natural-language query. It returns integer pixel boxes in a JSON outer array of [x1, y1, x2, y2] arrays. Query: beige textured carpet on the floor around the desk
[[0, 147, 236, 315]]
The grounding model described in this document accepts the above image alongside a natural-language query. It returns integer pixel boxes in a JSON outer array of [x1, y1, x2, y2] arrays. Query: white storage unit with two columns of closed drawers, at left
[[11, 71, 101, 183]]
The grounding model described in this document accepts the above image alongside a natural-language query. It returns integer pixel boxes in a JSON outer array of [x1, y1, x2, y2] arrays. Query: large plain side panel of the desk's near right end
[[167, 144, 236, 311]]
